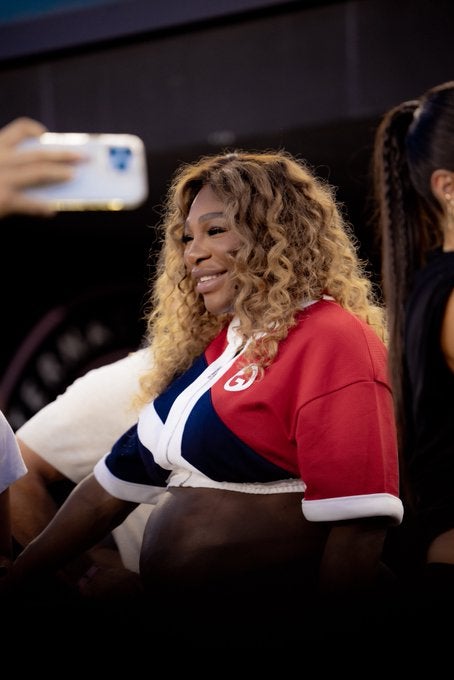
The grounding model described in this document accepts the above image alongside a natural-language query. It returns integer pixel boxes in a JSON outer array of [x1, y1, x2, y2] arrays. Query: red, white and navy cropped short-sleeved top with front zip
[[94, 299, 403, 524]]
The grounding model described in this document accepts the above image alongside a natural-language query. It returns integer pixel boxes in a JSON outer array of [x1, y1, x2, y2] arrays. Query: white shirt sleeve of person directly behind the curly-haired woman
[[16, 349, 151, 482]]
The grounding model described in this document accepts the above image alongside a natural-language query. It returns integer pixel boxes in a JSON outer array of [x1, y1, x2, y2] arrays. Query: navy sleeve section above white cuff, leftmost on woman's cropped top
[[106, 425, 169, 486]]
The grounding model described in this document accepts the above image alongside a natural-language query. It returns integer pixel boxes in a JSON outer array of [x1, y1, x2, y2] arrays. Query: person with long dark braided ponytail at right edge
[[373, 81, 454, 620]]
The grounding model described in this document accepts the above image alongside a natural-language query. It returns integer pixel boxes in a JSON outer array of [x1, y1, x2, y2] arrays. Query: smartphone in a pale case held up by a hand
[[21, 132, 148, 211]]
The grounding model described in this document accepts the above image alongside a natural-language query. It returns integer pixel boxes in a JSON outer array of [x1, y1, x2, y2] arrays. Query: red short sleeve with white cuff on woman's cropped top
[[297, 381, 403, 522]]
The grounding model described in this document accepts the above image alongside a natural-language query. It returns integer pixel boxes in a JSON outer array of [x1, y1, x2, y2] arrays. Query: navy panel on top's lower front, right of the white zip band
[[182, 392, 296, 483]]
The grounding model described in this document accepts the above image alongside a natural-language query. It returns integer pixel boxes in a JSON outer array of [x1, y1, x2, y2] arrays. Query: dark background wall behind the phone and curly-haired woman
[[0, 0, 454, 427]]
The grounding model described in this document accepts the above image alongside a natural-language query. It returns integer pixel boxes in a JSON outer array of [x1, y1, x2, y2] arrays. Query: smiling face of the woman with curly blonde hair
[[183, 186, 240, 314]]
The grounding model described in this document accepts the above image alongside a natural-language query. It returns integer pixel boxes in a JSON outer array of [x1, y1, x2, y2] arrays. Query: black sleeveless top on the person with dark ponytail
[[404, 250, 454, 543]]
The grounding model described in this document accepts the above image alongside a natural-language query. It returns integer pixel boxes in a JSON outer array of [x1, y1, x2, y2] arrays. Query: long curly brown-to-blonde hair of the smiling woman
[[137, 151, 385, 401]]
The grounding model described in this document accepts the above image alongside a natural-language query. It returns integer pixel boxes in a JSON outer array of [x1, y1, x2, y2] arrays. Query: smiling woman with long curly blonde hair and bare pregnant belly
[[3, 151, 402, 645]]
